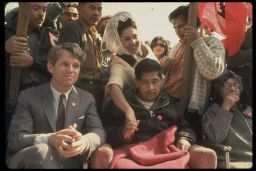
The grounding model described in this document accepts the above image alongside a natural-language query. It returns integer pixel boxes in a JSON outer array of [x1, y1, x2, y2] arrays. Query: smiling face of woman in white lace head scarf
[[120, 27, 139, 54]]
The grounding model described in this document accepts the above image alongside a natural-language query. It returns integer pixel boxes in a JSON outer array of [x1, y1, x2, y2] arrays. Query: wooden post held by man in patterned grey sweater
[[181, 2, 198, 112]]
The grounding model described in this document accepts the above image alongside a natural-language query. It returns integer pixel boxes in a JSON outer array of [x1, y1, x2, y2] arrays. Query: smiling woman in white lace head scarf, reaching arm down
[[103, 12, 157, 138]]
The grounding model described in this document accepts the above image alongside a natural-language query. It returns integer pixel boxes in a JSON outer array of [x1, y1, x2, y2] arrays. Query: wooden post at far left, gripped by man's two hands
[[8, 2, 30, 108]]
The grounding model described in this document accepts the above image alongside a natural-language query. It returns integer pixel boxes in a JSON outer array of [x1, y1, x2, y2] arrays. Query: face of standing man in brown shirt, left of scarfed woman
[[77, 2, 102, 27]]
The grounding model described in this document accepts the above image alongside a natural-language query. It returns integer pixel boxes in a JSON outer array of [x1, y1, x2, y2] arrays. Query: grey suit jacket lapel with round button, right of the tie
[[64, 88, 80, 128]]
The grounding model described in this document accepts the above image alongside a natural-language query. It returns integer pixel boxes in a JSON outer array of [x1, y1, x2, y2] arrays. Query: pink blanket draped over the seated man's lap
[[110, 126, 190, 168]]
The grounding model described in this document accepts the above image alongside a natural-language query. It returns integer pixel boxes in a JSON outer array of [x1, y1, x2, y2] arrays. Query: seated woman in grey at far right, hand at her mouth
[[202, 70, 252, 168]]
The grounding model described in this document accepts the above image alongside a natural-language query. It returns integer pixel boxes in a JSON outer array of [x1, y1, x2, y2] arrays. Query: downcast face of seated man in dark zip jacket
[[137, 72, 162, 102]]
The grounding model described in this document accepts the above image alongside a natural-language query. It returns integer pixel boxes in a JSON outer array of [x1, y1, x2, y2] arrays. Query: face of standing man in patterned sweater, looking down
[[171, 16, 187, 40]]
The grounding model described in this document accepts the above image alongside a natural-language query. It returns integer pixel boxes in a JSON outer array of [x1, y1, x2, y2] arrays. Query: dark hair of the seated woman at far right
[[211, 70, 243, 105]]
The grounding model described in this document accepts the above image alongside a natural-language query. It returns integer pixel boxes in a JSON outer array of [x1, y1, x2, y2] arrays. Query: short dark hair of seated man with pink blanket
[[135, 58, 163, 80]]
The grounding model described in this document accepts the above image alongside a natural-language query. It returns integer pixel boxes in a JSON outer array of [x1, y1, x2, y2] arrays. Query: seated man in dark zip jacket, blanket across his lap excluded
[[92, 59, 216, 168]]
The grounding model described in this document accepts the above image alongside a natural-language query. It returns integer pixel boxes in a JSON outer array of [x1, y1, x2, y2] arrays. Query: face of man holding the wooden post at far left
[[29, 2, 48, 28]]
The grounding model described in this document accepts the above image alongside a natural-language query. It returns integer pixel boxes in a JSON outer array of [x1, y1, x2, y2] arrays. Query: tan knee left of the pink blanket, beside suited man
[[91, 144, 114, 169]]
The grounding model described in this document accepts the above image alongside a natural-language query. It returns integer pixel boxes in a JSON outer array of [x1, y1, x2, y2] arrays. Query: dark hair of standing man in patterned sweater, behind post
[[168, 5, 200, 27]]
